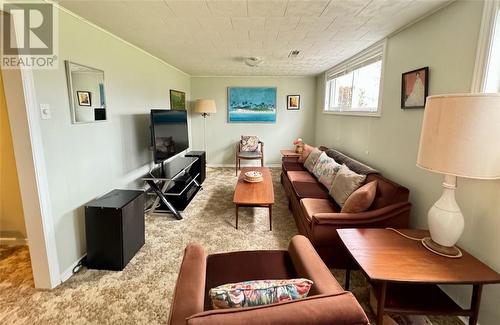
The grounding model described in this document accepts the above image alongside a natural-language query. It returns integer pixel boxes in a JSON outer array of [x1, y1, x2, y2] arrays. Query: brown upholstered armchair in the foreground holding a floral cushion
[[169, 235, 369, 325]]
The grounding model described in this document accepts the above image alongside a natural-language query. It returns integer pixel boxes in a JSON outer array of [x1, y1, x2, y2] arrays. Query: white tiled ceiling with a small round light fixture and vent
[[60, 0, 449, 75]]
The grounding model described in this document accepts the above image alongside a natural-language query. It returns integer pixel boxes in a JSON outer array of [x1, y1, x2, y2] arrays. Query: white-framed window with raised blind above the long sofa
[[324, 42, 385, 116]]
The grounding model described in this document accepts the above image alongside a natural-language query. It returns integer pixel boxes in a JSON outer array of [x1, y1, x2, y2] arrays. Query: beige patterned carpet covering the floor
[[0, 168, 461, 324]]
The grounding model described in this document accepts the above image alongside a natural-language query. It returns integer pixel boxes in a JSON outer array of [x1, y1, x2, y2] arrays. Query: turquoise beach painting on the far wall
[[227, 87, 276, 123]]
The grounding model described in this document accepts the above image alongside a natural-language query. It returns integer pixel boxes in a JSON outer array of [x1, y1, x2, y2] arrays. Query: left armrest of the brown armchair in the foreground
[[168, 244, 207, 325]]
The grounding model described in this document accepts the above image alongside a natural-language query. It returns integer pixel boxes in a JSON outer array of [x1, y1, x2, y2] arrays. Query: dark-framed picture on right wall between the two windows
[[401, 67, 429, 108]]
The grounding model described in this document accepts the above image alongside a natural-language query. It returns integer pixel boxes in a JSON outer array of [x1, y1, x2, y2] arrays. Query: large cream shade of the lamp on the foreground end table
[[417, 94, 500, 179]]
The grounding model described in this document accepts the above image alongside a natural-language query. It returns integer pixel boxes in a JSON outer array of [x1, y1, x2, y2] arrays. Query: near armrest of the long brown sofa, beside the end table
[[312, 202, 411, 228]]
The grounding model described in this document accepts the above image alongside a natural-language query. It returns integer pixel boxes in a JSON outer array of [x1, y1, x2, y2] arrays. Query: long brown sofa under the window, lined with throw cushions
[[281, 147, 411, 268]]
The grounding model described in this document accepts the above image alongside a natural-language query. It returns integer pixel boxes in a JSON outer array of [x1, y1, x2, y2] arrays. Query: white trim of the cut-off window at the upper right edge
[[471, 0, 500, 92]]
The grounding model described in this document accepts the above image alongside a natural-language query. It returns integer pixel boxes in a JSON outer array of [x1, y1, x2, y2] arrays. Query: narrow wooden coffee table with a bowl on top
[[233, 167, 274, 230]]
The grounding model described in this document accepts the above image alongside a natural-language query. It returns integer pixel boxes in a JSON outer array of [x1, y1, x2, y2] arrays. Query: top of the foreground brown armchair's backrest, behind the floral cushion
[[187, 291, 369, 325]]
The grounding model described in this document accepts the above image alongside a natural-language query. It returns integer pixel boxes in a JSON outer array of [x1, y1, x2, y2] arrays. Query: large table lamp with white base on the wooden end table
[[417, 94, 500, 257]]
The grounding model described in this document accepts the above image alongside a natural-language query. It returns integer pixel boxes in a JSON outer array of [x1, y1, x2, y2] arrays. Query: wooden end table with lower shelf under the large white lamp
[[337, 229, 500, 324]]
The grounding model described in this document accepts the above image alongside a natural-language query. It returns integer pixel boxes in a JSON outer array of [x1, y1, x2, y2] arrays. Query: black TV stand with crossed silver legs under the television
[[143, 157, 202, 220]]
